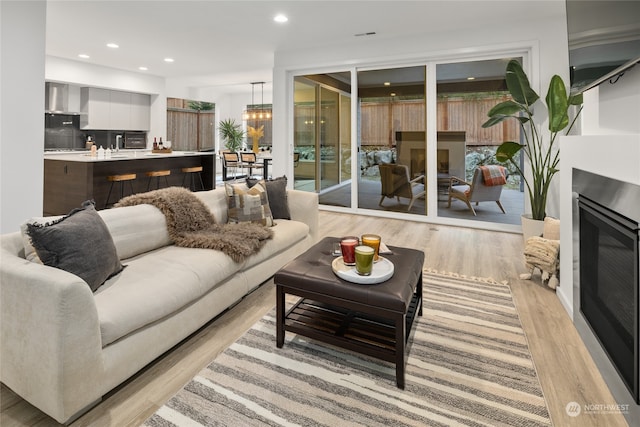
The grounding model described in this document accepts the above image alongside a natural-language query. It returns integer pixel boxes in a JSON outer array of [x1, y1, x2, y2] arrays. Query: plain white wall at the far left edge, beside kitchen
[[0, 1, 46, 233]]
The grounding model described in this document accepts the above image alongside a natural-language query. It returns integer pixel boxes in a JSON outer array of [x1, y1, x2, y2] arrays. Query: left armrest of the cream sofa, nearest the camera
[[0, 244, 104, 423]]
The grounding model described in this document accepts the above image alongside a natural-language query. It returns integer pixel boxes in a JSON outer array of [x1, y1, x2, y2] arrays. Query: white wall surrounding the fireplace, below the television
[[556, 66, 640, 318]]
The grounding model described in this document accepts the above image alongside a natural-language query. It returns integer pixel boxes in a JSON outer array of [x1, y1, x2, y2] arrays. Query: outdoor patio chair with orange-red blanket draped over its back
[[447, 165, 507, 216]]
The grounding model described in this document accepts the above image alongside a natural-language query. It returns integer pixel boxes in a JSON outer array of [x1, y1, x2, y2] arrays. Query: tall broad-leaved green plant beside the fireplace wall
[[482, 60, 582, 231]]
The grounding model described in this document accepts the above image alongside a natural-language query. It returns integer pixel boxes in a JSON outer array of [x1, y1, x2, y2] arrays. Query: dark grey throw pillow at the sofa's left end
[[27, 202, 124, 291]]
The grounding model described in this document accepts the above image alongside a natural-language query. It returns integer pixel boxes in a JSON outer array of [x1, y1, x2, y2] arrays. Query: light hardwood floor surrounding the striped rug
[[0, 212, 627, 427]]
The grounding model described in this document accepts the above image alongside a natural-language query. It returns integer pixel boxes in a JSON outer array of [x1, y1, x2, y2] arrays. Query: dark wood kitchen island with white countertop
[[43, 150, 216, 215]]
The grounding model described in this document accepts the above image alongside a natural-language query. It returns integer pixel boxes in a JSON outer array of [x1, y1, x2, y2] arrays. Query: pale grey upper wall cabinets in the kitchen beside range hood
[[80, 87, 151, 130]]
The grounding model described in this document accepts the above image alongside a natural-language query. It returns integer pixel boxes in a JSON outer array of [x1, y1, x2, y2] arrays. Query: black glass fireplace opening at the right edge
[[578, 194, 640, 403]]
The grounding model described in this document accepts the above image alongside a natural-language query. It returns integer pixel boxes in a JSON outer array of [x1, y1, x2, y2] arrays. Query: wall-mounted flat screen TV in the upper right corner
[[567, 0, 640, 93]]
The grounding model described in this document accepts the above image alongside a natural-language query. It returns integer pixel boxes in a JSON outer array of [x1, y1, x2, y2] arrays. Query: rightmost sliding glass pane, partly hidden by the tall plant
[[436, 58, 524, 225]]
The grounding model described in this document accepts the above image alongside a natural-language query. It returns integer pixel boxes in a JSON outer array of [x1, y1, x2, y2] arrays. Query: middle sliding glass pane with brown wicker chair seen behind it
[[358, 66, 427, 215]]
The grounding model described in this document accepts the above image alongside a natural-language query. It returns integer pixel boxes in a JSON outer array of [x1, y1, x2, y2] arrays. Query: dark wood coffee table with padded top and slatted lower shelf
[[274, 237, 424, 388]]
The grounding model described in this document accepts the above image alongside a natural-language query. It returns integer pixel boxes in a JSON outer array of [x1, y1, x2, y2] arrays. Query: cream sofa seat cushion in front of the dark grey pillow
[[95, 246, 241, 347]]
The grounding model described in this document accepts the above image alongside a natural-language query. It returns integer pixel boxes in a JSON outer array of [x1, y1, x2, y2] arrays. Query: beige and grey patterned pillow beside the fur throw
[[224, 181, 273, 227]]
